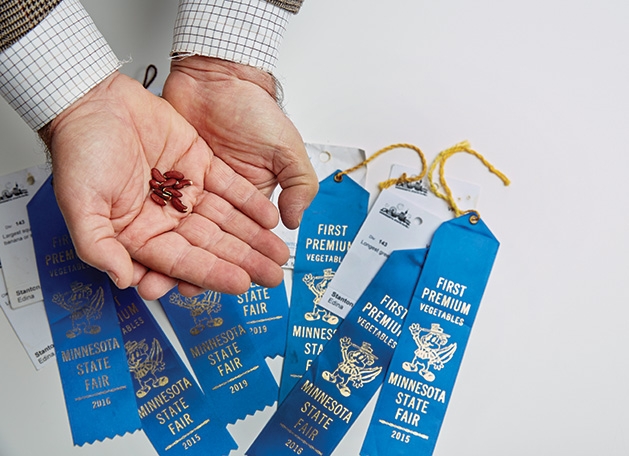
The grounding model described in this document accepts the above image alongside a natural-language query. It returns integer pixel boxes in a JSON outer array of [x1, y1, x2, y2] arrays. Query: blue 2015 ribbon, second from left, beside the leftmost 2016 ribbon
[[112, 287, 238, 456]]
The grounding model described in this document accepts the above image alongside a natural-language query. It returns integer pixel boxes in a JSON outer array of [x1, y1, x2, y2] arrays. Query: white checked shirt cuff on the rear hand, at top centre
[[170, 0, 291, 73]]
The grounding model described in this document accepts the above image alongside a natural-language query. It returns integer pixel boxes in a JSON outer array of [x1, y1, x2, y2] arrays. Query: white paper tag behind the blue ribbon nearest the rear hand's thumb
[[271, 143, 367, 269]]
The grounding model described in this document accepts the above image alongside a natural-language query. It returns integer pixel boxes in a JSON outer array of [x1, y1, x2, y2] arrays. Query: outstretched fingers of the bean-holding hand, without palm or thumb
[[134, 204, 288, 299]]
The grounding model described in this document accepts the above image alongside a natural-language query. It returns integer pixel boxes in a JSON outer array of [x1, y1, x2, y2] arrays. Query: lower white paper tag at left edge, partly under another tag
[[0, 266, 55, 370]]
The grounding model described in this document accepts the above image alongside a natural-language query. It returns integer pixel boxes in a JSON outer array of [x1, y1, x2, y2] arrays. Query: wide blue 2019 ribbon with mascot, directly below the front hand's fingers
[[160, 290, 278, 424]]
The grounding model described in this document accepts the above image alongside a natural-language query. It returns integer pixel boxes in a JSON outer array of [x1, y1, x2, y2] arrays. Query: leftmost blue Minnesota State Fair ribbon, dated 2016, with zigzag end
[[28, 178, 140, 445]]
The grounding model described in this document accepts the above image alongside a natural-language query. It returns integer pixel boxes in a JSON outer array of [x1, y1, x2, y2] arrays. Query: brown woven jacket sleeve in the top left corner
[[0, 0, 61, 52]]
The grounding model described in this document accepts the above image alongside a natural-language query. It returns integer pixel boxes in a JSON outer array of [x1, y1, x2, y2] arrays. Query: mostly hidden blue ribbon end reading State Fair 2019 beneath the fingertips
[[236, 281, 288, 358]]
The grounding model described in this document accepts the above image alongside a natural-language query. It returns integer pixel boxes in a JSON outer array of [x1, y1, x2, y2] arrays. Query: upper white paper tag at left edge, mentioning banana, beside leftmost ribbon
[[0, 165, 50, 309]]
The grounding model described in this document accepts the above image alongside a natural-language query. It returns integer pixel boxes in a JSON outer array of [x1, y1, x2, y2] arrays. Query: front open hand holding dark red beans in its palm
[[43, 72, 288, 299]]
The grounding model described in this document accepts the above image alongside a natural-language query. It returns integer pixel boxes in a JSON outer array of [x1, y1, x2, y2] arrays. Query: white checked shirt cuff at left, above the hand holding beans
[[0, 0, 121, 131]]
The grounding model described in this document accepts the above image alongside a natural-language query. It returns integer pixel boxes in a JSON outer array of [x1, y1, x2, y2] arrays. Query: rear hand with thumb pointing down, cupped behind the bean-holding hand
[[163, 56, 318, 228]]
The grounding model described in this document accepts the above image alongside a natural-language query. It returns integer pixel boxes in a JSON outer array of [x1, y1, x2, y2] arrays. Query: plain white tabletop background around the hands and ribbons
[[0, 0, 629, 456]]
